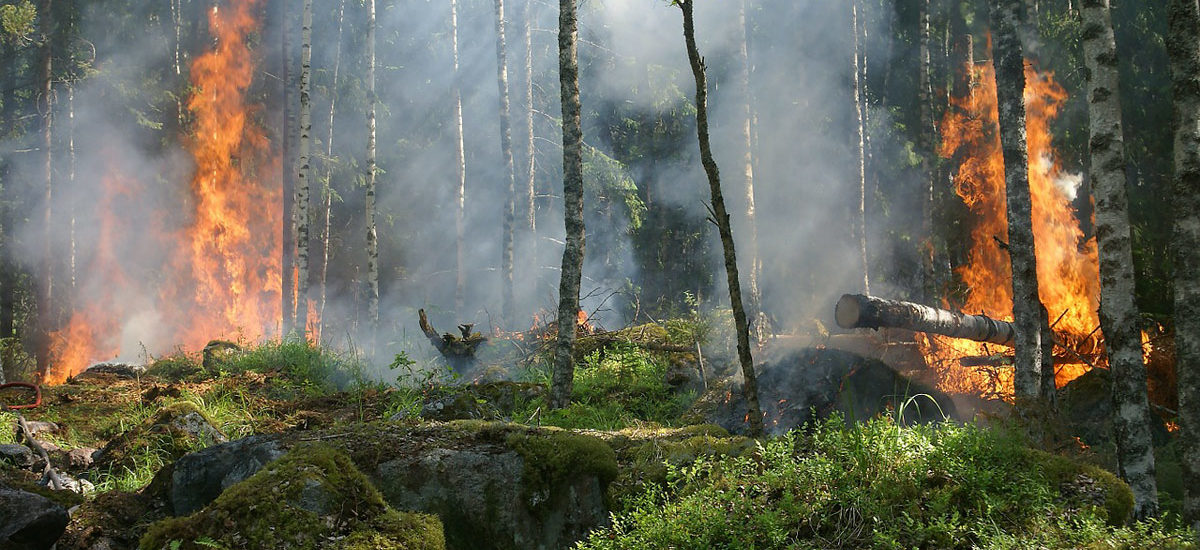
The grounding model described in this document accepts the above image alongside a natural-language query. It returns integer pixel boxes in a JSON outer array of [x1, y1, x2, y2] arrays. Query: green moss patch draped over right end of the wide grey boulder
[[505, 430, 617, 504]]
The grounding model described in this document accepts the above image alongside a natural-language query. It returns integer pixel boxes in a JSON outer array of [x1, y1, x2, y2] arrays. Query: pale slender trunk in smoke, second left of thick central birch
[[496, 0, 517, 324]]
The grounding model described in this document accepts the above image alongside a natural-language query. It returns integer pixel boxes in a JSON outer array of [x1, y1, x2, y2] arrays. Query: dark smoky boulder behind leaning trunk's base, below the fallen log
[[689, 348, 955, 434]]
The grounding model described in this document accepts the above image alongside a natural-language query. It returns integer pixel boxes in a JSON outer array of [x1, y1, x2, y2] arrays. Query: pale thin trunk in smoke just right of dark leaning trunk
[[738, 0, 768, 342]]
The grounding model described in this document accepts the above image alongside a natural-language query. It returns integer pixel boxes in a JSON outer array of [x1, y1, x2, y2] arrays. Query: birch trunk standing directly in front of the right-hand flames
[[990, 0, 1046, 402]]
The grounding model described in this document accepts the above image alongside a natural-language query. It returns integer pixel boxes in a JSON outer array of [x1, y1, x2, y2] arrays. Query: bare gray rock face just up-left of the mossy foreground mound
[[168, 436, 286, 515]]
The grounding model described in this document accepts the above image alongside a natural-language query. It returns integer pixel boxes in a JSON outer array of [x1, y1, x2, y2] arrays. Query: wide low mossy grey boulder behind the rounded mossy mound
[[166, 420, 617, 549]]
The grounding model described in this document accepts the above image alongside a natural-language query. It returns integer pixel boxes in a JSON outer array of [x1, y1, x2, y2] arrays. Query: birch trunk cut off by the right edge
[[1166, 0, 1200, 530]]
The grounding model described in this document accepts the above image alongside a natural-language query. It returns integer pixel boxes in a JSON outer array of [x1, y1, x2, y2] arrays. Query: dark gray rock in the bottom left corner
[[0, 485, 71, 550]]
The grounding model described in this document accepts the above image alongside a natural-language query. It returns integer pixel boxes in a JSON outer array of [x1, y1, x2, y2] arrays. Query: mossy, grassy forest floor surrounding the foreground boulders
[[0, 333, 1198, 550]]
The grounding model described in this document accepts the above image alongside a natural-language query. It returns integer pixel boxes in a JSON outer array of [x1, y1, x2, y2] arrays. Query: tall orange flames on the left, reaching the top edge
[[46, 0, 282, 383]]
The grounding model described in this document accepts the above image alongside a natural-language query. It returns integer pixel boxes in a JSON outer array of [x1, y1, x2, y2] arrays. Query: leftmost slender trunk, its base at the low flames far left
[[35, 0, 55, 381]]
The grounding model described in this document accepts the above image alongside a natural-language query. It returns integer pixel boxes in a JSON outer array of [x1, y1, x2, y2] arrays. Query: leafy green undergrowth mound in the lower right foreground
[[578, 418, 1194, 549]]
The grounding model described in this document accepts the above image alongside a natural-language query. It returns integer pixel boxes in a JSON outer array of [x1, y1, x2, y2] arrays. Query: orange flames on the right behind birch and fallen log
[[918, 48, 1103, 399]]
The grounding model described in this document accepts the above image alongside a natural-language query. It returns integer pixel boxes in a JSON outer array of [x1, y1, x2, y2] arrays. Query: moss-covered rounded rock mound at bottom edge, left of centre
[[139, 444, 445, 550]]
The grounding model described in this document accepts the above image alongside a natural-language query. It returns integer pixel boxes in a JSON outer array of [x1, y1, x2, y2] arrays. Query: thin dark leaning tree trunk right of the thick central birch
[[678, 0, 762, 437]]
